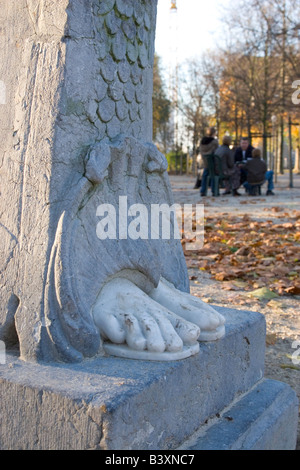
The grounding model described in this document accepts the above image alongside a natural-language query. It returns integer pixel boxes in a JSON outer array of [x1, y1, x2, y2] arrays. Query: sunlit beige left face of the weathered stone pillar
[[0, 0, 69, 360]]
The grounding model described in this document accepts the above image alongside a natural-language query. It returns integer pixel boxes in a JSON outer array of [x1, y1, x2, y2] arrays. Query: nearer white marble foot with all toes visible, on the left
[[93, 278, 200, 360]]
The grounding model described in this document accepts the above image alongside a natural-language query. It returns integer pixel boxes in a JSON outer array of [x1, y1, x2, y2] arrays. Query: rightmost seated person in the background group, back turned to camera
[[243, 149, 274, 196]]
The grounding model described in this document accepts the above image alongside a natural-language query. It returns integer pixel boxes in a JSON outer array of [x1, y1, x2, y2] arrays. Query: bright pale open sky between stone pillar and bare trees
[[155, 0, 230, 66]]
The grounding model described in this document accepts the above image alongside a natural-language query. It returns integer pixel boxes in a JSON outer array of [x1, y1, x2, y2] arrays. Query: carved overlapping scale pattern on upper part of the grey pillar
[[94, 0, 154, 139]]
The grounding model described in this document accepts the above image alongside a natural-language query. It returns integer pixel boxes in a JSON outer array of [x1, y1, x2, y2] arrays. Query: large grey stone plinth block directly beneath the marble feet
[[0, 308, 294, 450]]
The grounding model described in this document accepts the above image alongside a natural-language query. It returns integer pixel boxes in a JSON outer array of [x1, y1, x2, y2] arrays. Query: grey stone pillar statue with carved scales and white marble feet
[[0, 0, 225, 361]]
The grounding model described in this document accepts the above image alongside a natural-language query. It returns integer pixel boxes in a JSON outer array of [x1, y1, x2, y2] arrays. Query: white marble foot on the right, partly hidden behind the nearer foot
[[149, 279, 225, 341]]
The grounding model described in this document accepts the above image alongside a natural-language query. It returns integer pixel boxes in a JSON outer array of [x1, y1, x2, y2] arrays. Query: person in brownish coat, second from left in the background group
[[215, 135, 240, 196]]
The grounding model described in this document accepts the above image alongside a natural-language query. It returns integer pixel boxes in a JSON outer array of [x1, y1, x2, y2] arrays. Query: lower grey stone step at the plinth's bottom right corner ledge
[[180, 379, 299, 450]]
